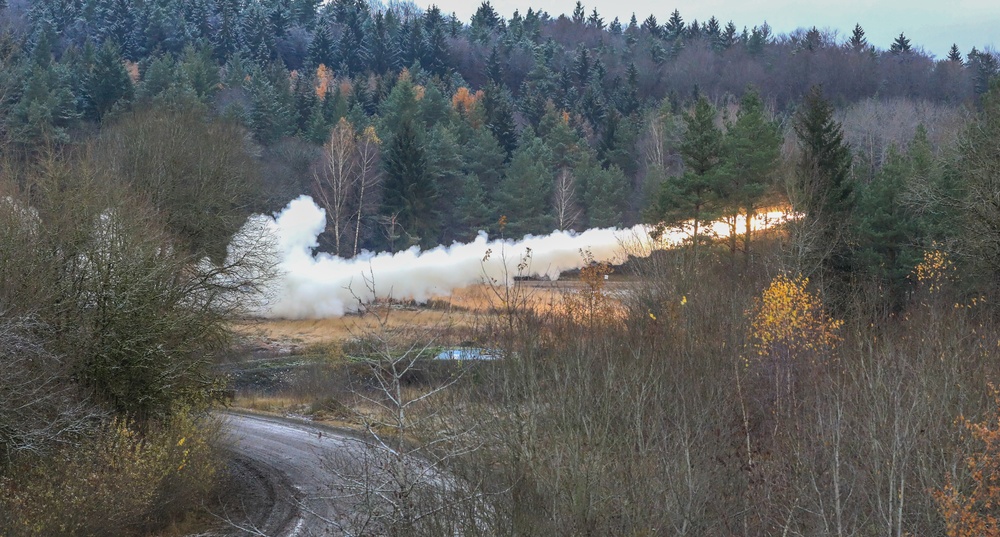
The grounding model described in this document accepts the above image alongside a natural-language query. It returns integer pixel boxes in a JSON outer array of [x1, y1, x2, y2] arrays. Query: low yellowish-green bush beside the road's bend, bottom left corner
[[0, 411, 219, 536]]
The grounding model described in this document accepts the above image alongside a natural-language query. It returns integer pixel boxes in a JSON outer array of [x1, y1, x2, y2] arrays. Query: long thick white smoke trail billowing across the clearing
[[253, 196, 783, 319]]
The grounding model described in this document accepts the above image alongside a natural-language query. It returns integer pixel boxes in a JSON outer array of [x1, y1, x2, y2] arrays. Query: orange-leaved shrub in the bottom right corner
[[932, 384, 1000, 537]]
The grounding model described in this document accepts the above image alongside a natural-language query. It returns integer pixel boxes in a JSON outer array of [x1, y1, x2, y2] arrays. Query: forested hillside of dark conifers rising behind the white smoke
[[0, 0, 998, 254]]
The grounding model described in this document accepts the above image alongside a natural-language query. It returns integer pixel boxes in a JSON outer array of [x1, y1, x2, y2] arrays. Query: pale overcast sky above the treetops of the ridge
[[417, 0, 1000, 58]]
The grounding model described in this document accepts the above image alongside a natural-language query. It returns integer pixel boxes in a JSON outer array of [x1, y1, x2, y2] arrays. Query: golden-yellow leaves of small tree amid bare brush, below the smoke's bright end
[[747, 274, 843, 363]]
